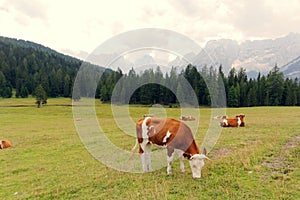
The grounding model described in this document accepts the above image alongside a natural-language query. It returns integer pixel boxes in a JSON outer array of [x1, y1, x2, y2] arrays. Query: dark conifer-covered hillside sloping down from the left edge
[[0, 37, 96, 98]]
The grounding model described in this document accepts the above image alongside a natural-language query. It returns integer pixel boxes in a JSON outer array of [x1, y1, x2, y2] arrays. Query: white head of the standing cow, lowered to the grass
[[189, 148, 209, 178]]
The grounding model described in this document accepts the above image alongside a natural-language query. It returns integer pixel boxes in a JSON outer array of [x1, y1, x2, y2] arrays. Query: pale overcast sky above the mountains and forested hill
[[0, 0, 300, 58]]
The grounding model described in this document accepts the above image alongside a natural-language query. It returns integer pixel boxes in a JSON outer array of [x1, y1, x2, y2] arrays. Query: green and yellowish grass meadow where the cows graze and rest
[[0, 98, 300, 200]]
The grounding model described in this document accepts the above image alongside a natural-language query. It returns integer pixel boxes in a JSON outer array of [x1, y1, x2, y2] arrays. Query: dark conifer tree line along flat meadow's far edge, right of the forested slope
[[97, 65, 300, 107]]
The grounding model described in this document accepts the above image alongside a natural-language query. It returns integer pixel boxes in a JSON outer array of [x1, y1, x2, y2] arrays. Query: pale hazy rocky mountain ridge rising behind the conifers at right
[[192, 33, 300, 77]]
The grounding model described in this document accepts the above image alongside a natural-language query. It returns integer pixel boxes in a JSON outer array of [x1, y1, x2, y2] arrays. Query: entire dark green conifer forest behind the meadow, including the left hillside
[[0, 37, 300, 107]]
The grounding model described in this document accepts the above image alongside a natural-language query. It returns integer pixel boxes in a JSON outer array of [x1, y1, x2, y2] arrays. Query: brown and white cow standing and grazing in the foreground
[[132, 117, 208, 178]]
